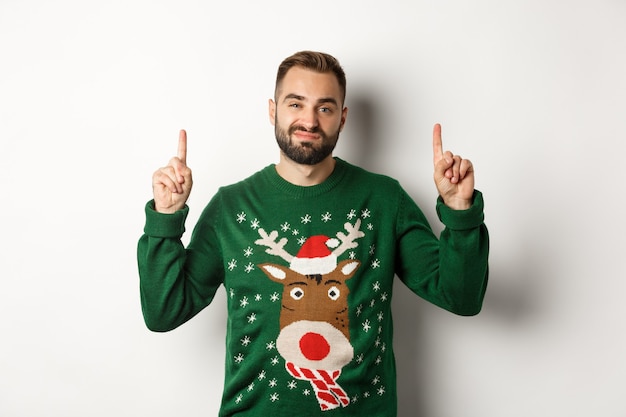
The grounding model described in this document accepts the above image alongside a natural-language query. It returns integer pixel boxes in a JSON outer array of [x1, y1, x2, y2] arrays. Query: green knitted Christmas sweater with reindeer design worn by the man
[[138, 158, 489, 417]]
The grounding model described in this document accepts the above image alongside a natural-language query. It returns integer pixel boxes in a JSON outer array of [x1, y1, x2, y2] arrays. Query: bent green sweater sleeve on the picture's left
[[137, 197, 223, 332]]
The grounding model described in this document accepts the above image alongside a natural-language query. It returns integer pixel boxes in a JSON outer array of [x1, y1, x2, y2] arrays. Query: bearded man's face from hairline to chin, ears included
[[269, 67, 348, 165]]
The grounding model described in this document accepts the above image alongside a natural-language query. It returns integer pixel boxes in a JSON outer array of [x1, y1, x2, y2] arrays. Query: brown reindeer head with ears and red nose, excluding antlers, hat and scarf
[[259, 260, 360, 370]]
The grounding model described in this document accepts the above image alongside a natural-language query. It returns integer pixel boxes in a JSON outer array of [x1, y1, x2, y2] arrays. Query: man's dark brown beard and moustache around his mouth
[[274, 120, 339, 165]]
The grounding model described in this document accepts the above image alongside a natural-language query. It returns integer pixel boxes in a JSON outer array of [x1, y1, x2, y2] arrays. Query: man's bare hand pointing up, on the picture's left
[[152, 130, 193, 214]]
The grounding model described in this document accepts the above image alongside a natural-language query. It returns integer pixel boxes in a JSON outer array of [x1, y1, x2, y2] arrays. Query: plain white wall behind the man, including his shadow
[[0, 0, 626, 417]]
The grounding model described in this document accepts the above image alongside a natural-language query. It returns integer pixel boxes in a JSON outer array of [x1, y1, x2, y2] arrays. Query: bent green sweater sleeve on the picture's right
[[396, 191, 489, 316]]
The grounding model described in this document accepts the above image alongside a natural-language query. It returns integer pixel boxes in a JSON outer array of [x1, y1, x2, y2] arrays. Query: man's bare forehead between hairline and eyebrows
[[276, 67, 343, 103]]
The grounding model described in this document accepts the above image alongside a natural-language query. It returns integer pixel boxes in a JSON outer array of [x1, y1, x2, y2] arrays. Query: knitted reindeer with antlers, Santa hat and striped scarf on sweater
[[255, 219, 365, 410]]
